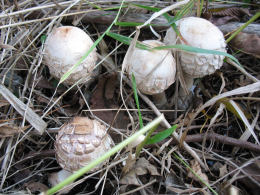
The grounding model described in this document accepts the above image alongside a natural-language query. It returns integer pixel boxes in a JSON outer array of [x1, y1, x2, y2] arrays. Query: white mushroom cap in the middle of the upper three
[[128, 40, 176, 95]]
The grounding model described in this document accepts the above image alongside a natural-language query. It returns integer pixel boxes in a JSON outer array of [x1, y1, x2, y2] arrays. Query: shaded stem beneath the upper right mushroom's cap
[[178, 72, 193, 110]]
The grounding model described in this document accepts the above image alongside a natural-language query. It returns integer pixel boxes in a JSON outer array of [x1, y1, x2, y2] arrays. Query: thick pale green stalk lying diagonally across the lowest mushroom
[[45, 115, 164, 195]]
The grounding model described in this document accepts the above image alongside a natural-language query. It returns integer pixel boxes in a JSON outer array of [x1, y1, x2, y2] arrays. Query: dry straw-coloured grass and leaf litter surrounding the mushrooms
[[0, 0, 260, 194]]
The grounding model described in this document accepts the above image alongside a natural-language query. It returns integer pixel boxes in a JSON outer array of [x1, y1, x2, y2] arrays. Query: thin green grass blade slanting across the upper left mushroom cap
[[59, 0, 124, 84]]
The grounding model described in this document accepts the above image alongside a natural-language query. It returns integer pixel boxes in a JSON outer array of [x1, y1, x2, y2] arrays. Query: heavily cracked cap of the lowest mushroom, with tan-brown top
[[55, 117, 113, 172]]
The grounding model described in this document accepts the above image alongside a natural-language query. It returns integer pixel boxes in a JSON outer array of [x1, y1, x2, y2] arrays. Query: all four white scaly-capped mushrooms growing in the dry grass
[[44, 17, 226, 191]]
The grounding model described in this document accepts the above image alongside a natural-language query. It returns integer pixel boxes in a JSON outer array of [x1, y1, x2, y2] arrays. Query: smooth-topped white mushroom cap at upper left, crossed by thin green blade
[[44, 26, 97, 85]]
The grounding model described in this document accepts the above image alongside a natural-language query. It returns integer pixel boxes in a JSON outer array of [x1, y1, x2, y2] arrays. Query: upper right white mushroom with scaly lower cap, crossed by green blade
[[164, 17, 226, 108]]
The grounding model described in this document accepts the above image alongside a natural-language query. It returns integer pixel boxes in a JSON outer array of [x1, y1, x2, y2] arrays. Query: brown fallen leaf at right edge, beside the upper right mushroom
[[230, 32, 260, 58]]
